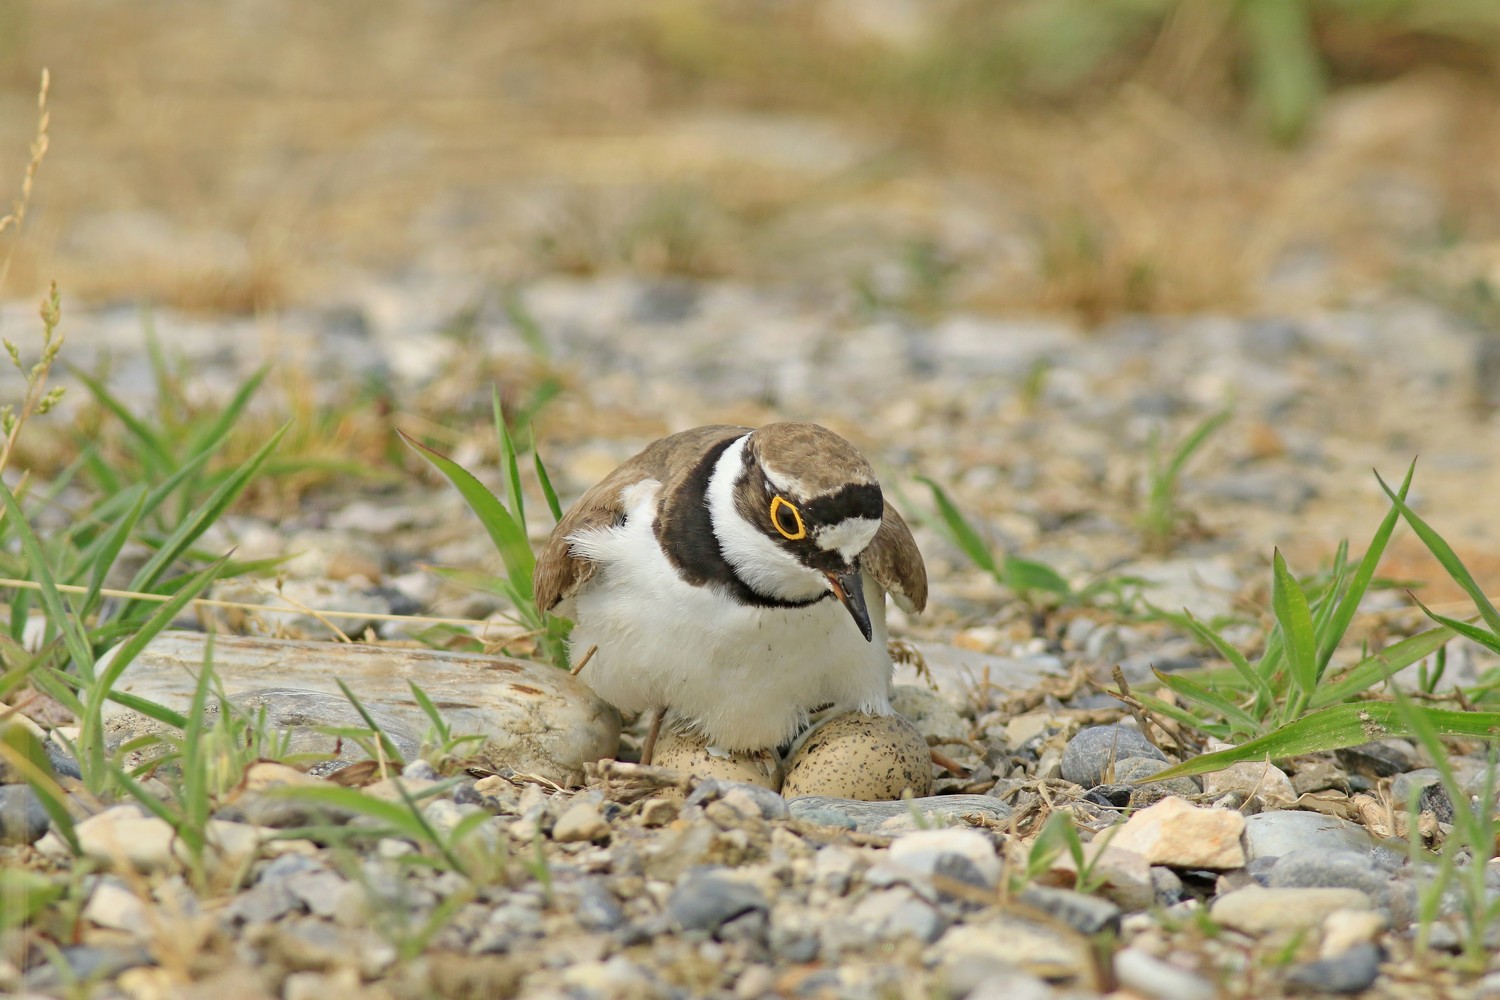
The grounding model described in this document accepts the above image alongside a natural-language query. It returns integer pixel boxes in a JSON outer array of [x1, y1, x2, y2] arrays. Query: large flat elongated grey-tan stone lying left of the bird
[[101, 631, 620, 784]]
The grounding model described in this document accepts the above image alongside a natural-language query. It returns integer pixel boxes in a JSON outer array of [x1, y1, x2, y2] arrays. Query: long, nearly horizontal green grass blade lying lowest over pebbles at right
[[1152, 702, 1500, 781]]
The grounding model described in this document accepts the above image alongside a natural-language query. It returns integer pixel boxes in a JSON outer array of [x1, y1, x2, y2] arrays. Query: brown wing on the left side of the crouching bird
[[531, 424, 756, 612]]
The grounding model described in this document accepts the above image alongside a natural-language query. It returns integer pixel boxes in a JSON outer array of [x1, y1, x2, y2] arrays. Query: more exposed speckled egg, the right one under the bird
[[782, 712, 933, 802]]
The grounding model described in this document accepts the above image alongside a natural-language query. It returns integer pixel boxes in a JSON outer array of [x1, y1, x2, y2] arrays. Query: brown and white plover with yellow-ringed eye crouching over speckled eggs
[[533, 421, 927, 763]]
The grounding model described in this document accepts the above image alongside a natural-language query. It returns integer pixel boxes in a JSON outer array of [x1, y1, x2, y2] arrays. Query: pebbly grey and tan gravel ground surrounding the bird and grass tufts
[[0, 279, 1500, 1000]]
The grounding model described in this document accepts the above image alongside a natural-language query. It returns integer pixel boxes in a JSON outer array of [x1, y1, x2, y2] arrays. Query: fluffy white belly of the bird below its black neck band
[[570, 485, 891, 750]]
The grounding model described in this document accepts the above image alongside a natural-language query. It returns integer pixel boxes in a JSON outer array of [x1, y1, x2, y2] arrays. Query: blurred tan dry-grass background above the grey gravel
[[0, 0, 1500, 324]]
